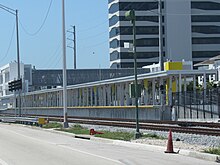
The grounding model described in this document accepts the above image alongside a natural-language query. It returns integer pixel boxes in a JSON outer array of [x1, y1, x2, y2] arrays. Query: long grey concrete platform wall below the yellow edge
[[1, 107, 171, 120]]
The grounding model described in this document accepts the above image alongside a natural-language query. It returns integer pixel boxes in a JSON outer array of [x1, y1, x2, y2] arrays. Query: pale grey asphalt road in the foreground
[[0, 123, 216, 165]]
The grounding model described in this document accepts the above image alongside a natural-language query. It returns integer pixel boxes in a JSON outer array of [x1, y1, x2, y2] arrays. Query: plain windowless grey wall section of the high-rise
[[164, 0, 192, 61]]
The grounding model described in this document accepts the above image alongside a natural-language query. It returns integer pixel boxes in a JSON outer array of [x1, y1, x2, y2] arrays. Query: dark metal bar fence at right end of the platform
[[172, 88, 220, 119]]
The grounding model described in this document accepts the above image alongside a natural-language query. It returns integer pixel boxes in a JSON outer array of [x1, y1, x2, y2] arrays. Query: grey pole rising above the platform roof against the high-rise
[[158, 0, 164, 71]]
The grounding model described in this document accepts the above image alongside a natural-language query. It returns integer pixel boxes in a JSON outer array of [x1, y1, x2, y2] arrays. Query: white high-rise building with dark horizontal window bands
[[109, 0, 220, 68]]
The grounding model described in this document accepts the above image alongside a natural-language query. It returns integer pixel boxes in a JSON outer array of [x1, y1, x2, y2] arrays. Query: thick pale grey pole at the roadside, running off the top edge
[[62, 0, 69, 128]]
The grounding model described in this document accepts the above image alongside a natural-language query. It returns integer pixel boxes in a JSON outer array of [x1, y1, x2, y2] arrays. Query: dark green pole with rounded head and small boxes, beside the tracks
[[125, 10, 141, 139]]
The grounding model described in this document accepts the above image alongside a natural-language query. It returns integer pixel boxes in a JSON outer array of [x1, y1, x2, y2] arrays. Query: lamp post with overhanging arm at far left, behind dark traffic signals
[[0, 4, 21, 116]]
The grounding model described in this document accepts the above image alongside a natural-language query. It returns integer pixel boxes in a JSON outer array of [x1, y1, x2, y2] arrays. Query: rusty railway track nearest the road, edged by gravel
[[1, 115, 220, 136]]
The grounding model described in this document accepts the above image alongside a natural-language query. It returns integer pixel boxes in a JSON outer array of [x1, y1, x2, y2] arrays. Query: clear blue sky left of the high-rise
[[0, 0, 110, 69]]
